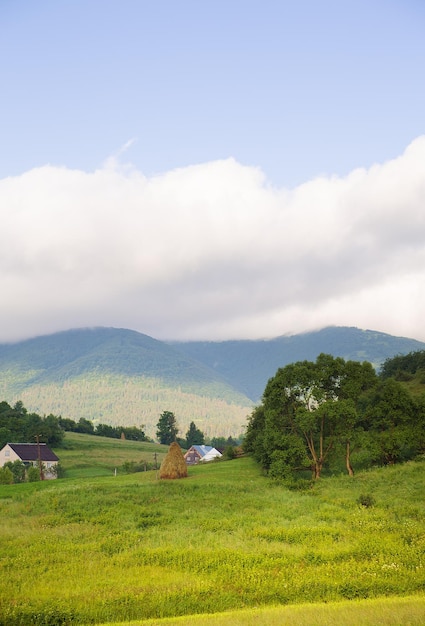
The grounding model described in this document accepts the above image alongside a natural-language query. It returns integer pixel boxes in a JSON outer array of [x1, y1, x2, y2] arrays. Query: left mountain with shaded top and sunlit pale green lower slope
[[0, 328, 251, 437]]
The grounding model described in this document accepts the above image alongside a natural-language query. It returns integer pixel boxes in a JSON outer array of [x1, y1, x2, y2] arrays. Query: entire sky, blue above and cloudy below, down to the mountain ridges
[[0, 0, 425, 342]]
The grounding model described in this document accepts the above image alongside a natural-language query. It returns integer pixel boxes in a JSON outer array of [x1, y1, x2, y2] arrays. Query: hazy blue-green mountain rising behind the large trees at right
[[174, 326, 425, 403]]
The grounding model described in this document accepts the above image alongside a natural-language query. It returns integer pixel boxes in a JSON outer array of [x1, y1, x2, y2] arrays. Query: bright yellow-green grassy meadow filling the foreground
[[0, 434, 425, 626]]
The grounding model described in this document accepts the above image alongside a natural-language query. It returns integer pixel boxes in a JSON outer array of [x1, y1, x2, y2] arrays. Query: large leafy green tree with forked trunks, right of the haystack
[[244, 354, 376, 479]]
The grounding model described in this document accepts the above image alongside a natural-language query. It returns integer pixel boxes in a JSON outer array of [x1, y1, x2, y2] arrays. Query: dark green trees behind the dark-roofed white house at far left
[[0, 401, 64, 448]]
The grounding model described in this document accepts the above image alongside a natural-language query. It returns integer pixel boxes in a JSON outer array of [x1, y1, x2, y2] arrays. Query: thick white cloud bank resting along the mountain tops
[[0, 137, 425, 341]]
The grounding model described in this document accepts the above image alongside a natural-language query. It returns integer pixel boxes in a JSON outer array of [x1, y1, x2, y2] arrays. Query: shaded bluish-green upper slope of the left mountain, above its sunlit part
[[0, 328, 237, 388]]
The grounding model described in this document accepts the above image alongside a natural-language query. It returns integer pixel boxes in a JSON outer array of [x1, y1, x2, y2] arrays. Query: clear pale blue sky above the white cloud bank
[[0, 0, 425, 186]]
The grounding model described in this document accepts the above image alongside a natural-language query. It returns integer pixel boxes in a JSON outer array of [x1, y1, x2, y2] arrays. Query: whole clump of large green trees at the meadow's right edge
[[244, 353, 425, 482]]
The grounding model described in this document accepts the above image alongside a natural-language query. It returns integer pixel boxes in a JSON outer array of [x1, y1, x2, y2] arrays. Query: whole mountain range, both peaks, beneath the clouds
[[0, 327, 425, 437]]
